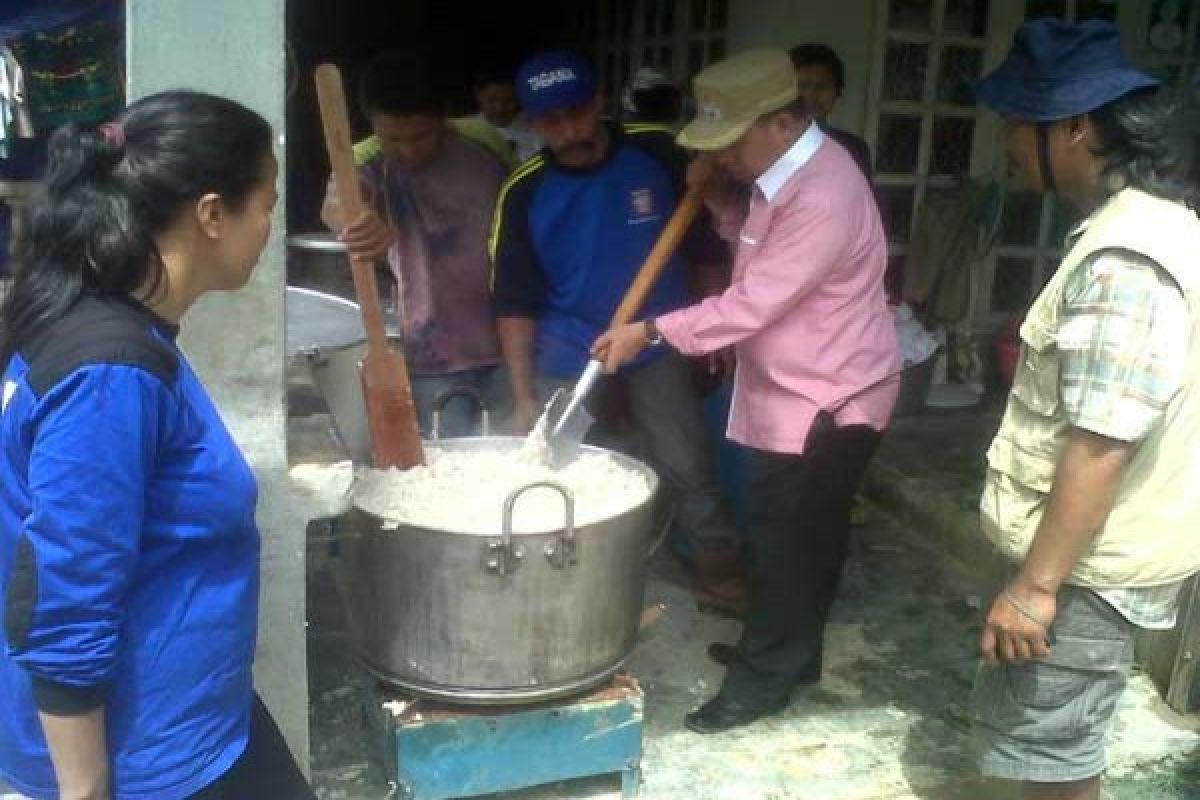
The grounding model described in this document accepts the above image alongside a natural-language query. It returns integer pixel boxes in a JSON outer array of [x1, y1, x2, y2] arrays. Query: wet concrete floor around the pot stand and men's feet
[[310, 510, 1200, 800]]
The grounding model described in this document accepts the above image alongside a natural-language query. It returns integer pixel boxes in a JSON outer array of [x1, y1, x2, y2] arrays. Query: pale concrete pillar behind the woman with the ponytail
[[127, 0, 308, 764]]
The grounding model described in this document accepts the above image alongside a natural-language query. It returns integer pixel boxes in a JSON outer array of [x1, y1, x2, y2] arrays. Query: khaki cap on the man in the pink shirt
[[678, 48, 799, 150]]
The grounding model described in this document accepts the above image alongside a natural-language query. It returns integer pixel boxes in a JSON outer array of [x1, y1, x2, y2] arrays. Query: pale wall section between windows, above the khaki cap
[[728, 0, 877, 133]]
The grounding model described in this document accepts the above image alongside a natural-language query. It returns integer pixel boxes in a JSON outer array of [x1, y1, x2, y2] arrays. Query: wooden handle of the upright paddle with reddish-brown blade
[[317, 64, 388, 351]]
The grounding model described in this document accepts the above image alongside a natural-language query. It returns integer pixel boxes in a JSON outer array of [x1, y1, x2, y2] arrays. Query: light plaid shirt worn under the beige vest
[[1057, 244, 1192, 630]]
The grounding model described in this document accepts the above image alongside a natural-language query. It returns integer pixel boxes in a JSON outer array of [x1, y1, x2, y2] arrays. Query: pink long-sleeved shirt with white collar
[[655, 125, 900, 453]]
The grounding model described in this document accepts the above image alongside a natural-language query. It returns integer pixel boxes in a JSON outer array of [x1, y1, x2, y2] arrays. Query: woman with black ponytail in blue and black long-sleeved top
[[0, 91, 313, 800]]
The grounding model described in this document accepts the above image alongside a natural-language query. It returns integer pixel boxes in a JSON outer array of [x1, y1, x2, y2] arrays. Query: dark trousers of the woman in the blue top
[[192, 693, 317, 800]]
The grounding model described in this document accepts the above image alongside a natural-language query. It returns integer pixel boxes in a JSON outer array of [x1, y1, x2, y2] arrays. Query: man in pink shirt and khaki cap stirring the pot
[[594, 50, 900, 733]]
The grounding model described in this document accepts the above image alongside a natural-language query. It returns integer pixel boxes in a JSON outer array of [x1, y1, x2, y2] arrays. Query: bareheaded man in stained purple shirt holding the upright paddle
[[322, 54, 508, 437]]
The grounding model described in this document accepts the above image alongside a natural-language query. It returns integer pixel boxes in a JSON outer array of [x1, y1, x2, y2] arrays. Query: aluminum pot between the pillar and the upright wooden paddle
[[287, 287, 400, 463]]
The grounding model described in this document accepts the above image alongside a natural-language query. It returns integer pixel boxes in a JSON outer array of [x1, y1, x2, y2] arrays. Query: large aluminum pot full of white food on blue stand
[[338, 437, 659, 704]]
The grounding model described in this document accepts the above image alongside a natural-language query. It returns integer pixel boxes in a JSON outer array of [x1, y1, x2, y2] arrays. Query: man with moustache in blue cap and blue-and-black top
[[491, 53, 745, 613]]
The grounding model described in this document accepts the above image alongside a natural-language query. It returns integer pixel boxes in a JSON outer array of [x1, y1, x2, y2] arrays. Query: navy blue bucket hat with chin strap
[[976, 18, 1158, 122]]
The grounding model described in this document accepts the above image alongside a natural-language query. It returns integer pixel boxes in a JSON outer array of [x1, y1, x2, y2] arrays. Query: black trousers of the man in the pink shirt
[[721, 414, 880, 704]]
